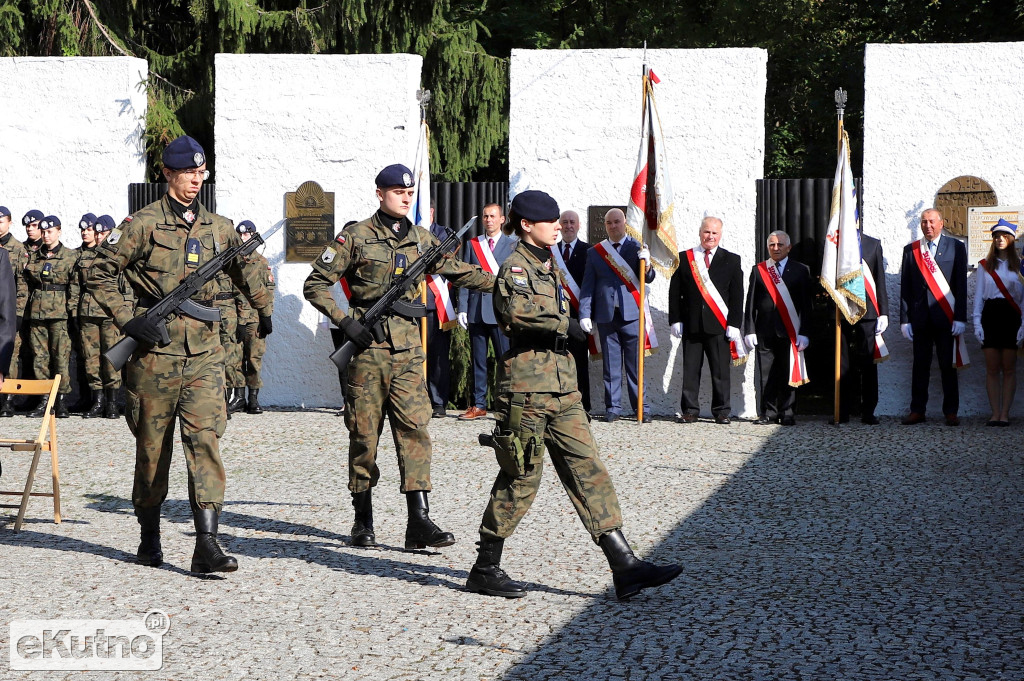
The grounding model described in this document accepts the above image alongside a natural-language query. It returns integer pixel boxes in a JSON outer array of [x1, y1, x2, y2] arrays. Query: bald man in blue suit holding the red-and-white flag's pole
[[580, 208, 654, 422]]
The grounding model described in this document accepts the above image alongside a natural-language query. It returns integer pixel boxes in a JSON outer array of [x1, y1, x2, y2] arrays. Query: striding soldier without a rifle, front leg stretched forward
[[466, 190, 682, 599]]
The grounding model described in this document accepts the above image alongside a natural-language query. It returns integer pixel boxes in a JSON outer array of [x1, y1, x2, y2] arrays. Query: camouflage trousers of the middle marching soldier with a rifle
[[345, 346, 431, 493]]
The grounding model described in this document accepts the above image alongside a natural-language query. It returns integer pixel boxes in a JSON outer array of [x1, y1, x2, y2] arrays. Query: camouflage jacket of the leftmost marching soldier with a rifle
[[87, 195, 271, 355]]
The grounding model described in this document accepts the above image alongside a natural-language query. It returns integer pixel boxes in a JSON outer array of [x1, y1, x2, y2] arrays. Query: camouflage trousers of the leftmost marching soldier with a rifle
[[125, 347, 227, 512]]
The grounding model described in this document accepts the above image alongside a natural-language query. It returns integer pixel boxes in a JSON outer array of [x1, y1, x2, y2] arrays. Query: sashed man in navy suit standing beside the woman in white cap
[[899, 208, 967, 426]]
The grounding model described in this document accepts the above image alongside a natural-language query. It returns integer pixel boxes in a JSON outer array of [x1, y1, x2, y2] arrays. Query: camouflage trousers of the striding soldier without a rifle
[[480, 392, 623, 542]]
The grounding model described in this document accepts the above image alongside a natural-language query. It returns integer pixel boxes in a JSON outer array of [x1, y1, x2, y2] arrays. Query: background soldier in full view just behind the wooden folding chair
[[25, 215, 79, 419]]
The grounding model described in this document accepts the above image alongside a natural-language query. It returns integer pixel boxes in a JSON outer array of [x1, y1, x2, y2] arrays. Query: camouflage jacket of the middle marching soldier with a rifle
[[302, 213, 495, 350]]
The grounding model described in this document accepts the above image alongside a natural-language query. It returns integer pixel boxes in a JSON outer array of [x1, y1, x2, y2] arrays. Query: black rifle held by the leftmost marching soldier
[[103, 220, 285, 371]]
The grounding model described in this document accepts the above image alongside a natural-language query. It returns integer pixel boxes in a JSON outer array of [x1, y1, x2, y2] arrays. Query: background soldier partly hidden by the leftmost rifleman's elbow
[[75, 215, 124, 419]]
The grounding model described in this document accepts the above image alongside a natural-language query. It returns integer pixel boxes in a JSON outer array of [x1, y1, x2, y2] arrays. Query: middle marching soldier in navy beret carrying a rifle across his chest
[[303, 165, 494, 549]]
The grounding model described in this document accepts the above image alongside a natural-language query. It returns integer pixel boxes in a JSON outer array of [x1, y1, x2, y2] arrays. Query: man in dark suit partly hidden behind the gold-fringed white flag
[[839, 232, 889, 426]]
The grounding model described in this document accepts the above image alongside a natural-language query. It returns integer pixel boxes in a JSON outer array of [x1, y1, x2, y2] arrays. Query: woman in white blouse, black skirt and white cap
[[974, 219, 1024, 426]]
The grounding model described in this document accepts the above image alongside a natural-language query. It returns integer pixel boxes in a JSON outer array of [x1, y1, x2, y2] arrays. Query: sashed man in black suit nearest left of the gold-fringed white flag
[[743, 231, 811, 426]]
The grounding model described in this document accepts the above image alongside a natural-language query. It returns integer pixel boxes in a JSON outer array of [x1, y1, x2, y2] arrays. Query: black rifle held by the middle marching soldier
[[331, 215, 476, 371]]
